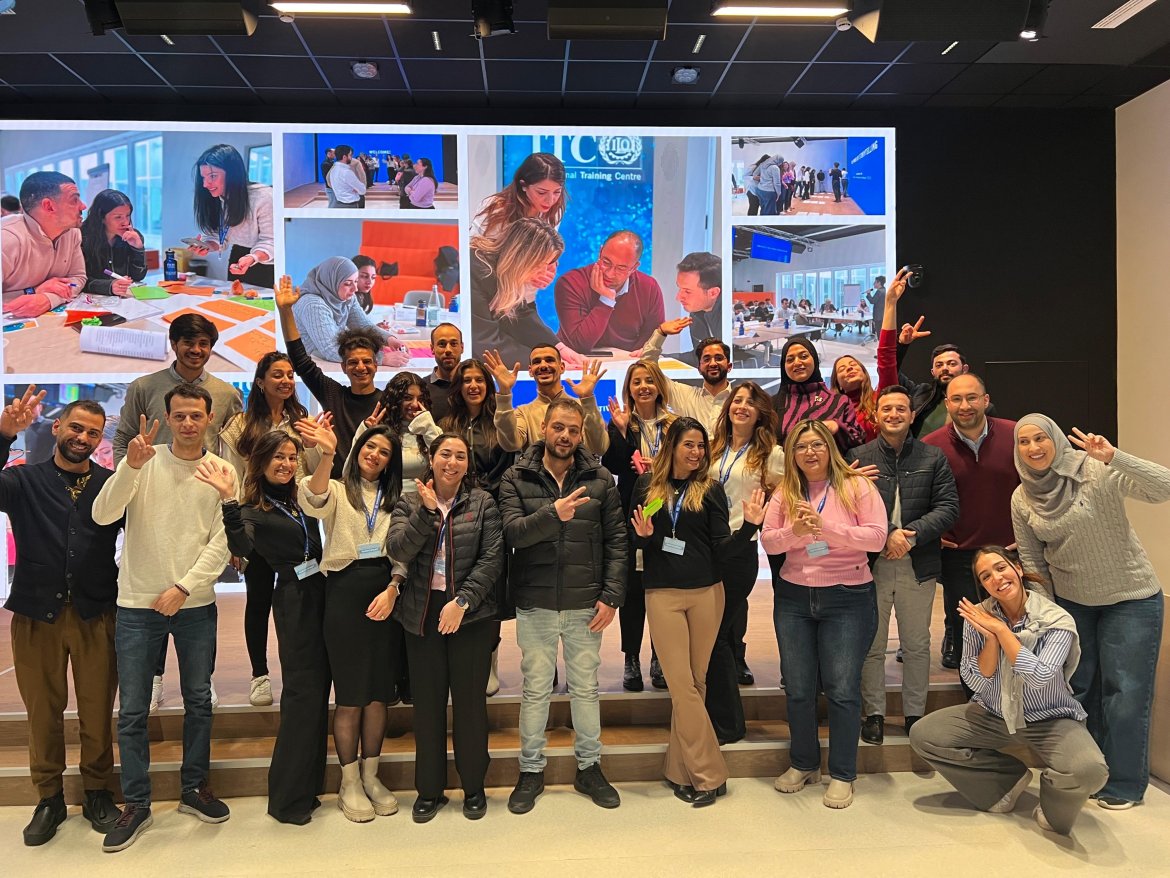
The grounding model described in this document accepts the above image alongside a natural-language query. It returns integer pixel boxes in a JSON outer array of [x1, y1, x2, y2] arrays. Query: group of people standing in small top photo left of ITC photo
[[321, 144, 439, 211]]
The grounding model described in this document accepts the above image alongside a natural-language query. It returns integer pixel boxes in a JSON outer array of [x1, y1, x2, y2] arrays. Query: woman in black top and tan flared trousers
[[632, 418, 767, 808]]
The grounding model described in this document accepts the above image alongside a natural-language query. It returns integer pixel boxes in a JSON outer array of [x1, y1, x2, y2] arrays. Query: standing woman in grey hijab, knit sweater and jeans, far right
[[1012, 414, 1170, 810]]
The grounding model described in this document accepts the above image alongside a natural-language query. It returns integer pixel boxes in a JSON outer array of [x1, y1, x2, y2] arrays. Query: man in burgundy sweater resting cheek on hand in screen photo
[[553, 229, 666, 355]]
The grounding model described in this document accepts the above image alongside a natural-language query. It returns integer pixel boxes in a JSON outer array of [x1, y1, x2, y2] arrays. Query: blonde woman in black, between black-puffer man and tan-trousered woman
[[601, 359, 674, 692]]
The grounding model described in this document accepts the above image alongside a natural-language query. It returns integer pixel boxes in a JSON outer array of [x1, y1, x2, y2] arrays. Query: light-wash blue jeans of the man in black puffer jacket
[[516, 606, 601, 771]]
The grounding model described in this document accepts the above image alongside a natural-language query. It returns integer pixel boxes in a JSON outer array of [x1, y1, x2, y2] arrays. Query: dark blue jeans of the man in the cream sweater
[[115, 604, 218, 807]]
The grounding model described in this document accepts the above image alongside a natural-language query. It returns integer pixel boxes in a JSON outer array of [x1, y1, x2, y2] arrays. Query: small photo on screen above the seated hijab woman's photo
[[283, 131, 459, 211]]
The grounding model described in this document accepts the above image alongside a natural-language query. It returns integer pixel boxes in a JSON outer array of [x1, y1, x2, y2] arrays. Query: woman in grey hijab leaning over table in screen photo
[[293, 256, 410, 365]]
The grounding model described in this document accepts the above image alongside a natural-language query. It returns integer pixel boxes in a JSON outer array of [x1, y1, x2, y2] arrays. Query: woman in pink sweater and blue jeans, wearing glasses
[[761, 420, 888, 808]]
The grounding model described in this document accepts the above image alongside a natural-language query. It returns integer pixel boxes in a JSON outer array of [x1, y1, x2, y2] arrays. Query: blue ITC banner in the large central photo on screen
[[501, 135, 654, 334]]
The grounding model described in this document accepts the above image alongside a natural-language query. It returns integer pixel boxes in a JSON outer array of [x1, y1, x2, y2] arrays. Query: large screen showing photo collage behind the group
[[0, 122, 897, 597]]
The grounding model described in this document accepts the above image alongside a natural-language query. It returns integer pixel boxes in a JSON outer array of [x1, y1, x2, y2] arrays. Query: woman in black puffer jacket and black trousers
[[386, 433, 504, 823]]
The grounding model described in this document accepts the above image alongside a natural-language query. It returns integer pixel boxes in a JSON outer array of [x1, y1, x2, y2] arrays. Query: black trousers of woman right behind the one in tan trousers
[[706, 542, 759, 743]]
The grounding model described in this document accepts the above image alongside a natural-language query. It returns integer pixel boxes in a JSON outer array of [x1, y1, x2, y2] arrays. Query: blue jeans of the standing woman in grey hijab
[[1057, 592, 1163, 802]]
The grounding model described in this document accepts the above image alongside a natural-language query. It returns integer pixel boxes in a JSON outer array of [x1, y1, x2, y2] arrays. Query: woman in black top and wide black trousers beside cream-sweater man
[[195, 431, 331, 825]]
